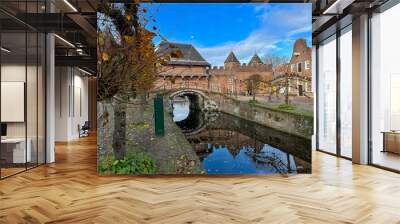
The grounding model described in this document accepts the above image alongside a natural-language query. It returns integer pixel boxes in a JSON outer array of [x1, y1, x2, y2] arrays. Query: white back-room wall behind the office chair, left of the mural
[[55, 67, 89, 141]]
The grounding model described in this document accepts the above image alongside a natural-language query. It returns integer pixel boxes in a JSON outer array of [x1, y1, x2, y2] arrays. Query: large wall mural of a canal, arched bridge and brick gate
[[97, 3, 314, 175]]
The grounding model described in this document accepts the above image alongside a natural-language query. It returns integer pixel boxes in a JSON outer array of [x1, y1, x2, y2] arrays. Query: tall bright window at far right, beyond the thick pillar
[[370, 4, 400, 170]]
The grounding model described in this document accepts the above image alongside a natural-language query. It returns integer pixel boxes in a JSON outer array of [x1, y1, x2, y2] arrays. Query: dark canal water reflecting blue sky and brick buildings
[[173, 98, 311, 174]]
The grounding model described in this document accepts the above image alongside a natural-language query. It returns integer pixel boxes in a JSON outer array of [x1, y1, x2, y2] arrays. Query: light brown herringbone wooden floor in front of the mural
[[0, 138, 400, 224]]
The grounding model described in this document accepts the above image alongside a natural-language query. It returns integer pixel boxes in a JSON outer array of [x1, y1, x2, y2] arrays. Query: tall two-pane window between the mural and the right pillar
[[318, 26, 353, 158]]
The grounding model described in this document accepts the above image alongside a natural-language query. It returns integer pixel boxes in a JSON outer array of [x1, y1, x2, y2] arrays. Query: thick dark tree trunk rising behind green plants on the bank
[[113, 101, 126, 159]]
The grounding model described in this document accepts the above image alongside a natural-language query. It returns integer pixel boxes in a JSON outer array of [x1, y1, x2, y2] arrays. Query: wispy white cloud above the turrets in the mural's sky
[[197, 4, 311, 66]]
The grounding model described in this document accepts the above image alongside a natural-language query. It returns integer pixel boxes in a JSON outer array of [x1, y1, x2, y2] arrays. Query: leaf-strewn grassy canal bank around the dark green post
[[98, 100, 203, 174]]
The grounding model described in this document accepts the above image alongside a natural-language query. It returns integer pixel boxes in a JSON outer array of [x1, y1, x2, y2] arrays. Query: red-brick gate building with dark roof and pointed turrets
[[156, 42, 273, 94]]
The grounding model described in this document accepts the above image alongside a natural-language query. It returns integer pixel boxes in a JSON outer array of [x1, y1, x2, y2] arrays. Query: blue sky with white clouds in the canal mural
[[143, 3, 311, 66]]
